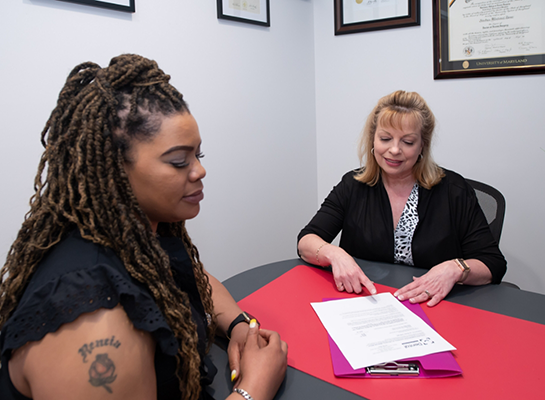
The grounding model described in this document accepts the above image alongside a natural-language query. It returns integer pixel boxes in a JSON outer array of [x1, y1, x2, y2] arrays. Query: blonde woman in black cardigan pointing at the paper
[[298, 91, 506, 306]]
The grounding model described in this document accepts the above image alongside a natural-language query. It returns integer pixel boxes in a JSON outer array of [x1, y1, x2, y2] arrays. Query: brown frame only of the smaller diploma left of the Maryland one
[[335, 0, 420, 35]]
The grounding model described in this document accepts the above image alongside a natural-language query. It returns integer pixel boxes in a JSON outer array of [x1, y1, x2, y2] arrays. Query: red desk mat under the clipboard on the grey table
[[238, 265, 545, 400]]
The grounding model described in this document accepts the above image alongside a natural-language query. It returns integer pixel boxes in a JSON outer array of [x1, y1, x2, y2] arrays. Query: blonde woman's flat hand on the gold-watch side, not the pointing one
[[394, 260, 461, 307]]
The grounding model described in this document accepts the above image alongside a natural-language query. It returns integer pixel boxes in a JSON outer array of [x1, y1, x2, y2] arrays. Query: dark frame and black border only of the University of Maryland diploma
[[433, 0, 545, 79]]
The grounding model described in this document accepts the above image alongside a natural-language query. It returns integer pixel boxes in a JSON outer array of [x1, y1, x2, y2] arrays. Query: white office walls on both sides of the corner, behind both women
[[0, 0, 545, 293]]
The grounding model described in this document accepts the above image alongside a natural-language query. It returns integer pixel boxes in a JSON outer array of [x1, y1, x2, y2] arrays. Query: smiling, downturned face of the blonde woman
[[373, 117, 423, 179]]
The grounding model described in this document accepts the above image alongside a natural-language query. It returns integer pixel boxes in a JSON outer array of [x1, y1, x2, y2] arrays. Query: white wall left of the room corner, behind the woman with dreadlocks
[[0, 0, 317, 279]]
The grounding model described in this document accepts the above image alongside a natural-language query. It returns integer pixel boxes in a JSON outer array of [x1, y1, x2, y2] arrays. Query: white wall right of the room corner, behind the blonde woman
[[308, 1, 545, 293]]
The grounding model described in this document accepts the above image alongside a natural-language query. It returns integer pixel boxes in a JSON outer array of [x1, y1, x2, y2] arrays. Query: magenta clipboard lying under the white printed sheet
[[323, 299, 462, 379]]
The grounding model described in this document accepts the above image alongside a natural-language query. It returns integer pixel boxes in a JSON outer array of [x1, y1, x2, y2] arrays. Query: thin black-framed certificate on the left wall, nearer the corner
[[217, 0, 271, 26]]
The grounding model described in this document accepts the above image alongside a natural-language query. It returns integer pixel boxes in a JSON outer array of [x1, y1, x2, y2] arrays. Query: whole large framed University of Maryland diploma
[[433, 0, 545, 79]]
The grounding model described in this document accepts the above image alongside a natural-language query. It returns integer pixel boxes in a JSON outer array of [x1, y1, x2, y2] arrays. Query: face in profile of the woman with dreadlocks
[[125, 112, 206, 231]]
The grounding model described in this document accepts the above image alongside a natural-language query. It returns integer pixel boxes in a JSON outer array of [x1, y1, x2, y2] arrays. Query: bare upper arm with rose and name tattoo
[[9, 306, 157, 400]]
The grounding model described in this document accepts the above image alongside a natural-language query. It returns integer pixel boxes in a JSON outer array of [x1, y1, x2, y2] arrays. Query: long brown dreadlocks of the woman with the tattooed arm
[[0, 54, 216, 399]]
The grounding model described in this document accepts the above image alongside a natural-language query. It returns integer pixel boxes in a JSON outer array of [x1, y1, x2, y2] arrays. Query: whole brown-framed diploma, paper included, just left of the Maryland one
[[335, 0, 420, 35]]
